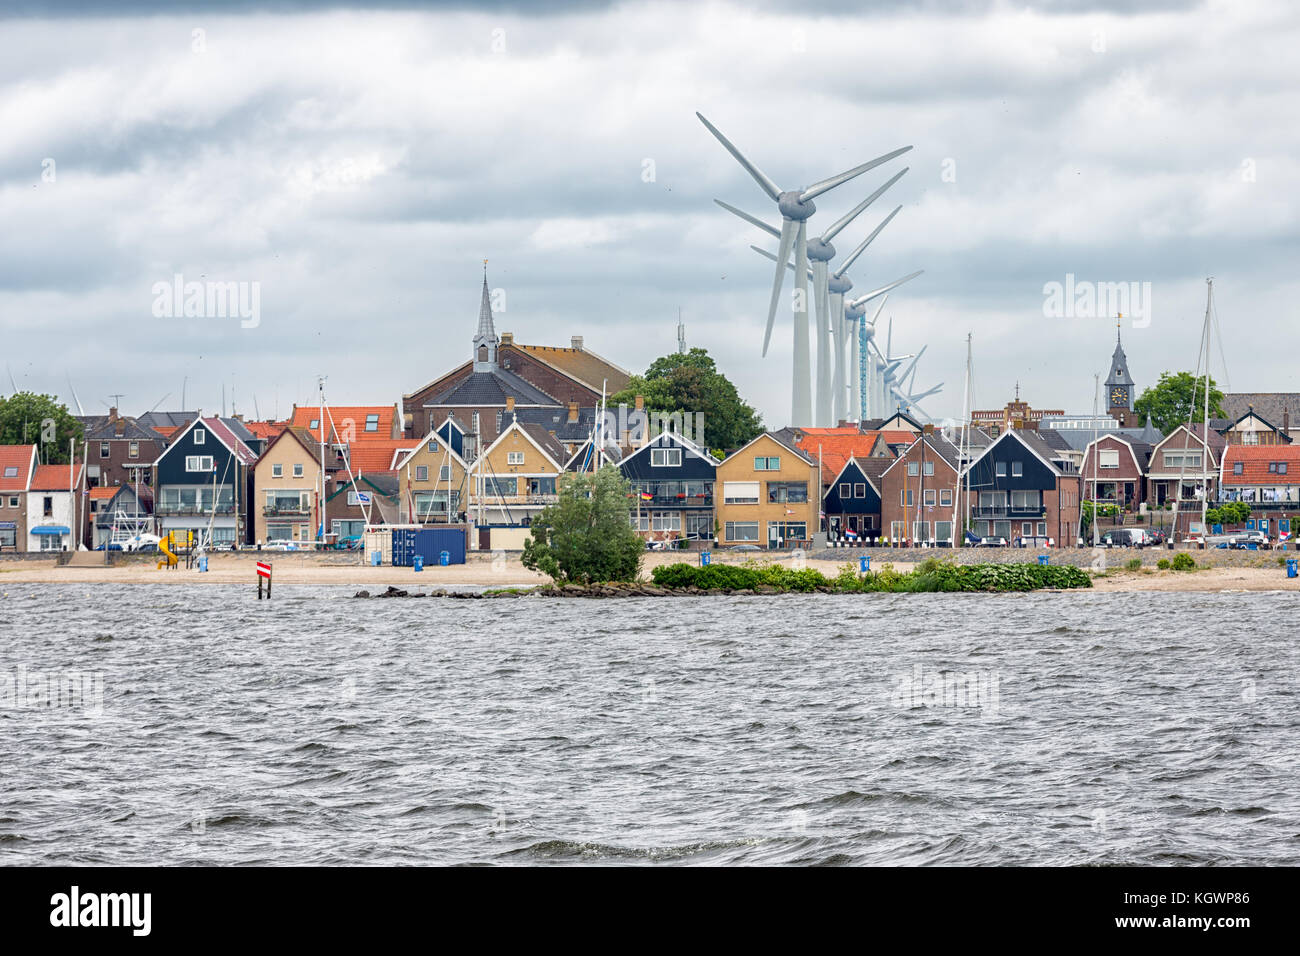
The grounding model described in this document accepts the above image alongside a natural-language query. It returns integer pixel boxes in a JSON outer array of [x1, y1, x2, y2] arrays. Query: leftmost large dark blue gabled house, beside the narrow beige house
[[153, 418, 257, 548]]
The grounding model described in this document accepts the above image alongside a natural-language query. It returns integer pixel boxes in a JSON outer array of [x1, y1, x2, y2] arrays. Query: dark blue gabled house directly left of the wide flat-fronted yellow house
[[619, 432, 718, 541]]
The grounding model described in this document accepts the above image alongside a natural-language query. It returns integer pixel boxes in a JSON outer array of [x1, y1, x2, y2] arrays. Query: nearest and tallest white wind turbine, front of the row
[[696, 112, 911, 425]]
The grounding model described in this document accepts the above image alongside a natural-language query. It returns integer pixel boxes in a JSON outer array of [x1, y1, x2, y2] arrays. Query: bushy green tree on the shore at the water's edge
[[523, 466, 645, 584]]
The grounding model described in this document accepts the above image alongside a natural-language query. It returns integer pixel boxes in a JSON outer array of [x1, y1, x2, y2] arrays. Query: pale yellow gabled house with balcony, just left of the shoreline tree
[[469, 419, 567, 525]]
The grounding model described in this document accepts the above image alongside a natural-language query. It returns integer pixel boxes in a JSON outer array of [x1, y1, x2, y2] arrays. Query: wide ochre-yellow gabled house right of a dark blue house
[[714, 432, 822, 548]]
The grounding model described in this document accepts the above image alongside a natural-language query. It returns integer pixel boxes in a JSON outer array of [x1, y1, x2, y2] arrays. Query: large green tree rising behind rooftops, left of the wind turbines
[[610, 349, 763, 449]]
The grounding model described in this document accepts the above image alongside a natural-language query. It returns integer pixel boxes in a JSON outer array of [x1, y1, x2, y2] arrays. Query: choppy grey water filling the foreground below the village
[[0, 585, 1300, 865]]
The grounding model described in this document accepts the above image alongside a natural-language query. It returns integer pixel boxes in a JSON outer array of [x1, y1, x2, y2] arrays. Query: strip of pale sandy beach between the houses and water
[[0, 551, 1300, 593]]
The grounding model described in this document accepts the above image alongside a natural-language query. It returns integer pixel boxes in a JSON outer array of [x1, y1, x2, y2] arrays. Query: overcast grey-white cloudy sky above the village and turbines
[[0, 0, 1300, 425]]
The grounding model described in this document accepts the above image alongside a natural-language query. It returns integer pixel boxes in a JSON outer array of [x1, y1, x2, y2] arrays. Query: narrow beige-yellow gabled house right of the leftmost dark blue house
[[251, 427, 321, 548]]
